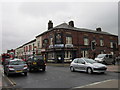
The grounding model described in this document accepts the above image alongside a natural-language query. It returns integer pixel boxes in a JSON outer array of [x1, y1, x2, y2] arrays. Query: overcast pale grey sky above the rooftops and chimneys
[[0, 0, 118, 53]]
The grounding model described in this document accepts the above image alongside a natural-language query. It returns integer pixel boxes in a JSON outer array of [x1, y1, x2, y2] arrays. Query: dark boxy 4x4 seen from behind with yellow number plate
[[26, 56, 46, 72]]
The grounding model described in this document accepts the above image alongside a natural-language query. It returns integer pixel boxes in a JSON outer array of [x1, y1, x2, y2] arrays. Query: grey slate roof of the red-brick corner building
[[36, 23, 116, 37]]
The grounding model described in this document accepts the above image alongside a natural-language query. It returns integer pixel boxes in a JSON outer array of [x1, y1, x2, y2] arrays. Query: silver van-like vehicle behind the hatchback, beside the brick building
[[95, 54, 115, 64]]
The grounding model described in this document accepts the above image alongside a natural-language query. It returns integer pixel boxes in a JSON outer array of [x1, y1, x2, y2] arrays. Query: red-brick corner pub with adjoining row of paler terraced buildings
[[15, 20, 119, 63]]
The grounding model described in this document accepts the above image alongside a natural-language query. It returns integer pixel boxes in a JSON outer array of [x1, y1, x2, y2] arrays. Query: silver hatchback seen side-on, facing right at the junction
[[70, 58, 107, 74]]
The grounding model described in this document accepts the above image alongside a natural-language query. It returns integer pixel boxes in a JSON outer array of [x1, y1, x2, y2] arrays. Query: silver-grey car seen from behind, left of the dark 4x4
[[4, 59, 28, 76]]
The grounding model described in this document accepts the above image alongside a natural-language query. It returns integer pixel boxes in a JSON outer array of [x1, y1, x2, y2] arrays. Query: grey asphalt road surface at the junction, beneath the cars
[[2, 66, 118, 88]]
